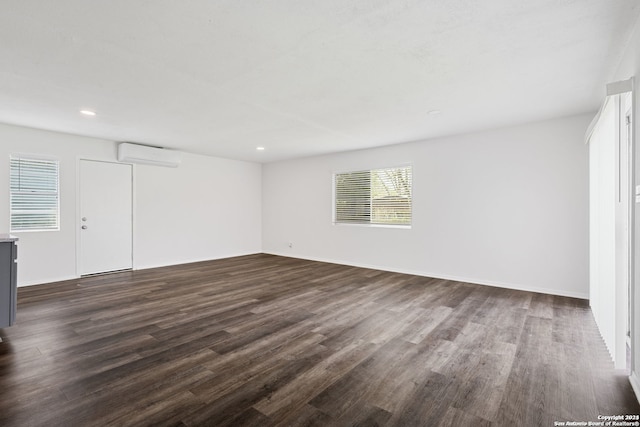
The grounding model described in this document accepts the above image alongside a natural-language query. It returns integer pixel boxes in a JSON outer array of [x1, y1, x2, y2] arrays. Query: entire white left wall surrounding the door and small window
[[0, 124, 261, 285]]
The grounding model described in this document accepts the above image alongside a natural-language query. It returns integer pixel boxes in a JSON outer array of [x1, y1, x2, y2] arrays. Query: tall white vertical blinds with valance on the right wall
[[589, 93, 632, 369]]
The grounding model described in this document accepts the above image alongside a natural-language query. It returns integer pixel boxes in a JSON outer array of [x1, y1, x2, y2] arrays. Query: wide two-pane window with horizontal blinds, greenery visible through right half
[[334, 166, 412, 225]]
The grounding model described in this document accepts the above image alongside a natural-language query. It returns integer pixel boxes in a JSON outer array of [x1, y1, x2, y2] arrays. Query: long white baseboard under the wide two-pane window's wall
[[264, 252, 589, 300]]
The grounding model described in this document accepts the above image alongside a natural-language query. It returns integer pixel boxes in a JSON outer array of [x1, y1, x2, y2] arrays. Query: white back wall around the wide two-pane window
[[262, 115, 592, 298]]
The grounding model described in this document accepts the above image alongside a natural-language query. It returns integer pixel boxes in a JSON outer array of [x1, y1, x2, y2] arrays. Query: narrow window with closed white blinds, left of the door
[[10, 157, 60, 231]]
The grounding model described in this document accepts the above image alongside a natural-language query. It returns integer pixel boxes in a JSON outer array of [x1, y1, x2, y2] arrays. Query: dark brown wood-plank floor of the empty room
[[0, 255, 640, 427]]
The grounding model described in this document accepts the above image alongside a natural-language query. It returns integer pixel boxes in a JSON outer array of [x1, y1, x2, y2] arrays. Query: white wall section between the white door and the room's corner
[[134, 153, 262, 268]]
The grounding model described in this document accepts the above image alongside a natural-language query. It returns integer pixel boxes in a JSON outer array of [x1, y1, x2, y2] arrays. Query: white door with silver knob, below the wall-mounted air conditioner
[[78, 160, 133, 275]]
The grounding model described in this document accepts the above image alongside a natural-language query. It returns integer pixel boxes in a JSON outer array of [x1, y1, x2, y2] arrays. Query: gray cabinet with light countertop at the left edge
[[0, 234, 18, 328]]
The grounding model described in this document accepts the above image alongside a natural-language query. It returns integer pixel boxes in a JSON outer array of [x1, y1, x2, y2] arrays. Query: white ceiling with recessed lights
[[0, 0, 640, 162]]
